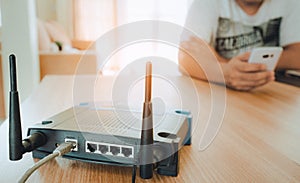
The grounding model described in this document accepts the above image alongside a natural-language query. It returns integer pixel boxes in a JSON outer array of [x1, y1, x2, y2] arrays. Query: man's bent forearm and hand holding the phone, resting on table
[[179, 38, 274, 91]]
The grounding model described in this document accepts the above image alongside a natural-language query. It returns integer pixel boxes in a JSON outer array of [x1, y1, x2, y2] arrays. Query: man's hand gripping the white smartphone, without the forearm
[[221, 52, 275, 91]]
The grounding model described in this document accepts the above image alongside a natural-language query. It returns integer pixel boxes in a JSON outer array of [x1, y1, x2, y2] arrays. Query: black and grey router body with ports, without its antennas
[[28, 106, 191, 176]]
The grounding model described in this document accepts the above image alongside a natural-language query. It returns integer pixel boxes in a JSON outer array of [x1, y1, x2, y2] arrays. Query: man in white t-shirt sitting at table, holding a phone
[[179, 0, 300, 91]]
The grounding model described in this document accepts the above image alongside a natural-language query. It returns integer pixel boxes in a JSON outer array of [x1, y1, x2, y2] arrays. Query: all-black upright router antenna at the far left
[[9, 54, 24, 160]]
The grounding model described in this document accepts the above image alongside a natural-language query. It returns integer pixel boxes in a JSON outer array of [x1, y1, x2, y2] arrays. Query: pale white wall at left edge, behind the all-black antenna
[[1, 0, 40, 116]]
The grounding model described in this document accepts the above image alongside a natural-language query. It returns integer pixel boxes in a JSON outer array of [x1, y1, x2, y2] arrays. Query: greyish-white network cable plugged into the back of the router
[[19, 142, 76, 183]]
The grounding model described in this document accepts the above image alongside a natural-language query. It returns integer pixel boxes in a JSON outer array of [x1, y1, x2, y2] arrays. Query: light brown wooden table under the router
[[0, 76, 300, 182]]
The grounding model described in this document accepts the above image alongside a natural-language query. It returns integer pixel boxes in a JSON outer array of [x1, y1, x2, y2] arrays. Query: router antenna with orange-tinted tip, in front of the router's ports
[[140, 62, 153, 179]]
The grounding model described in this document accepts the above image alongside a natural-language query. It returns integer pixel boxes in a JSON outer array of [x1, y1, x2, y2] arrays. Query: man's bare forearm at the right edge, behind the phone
[[276, 43, 300, 70]]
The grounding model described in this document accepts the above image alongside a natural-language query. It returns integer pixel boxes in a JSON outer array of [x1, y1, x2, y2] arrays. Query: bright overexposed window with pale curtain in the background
[[73, 0, 191, 73]]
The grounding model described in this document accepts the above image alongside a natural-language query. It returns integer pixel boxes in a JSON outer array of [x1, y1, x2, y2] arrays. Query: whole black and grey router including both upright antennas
[[9, 55, 191, 179]]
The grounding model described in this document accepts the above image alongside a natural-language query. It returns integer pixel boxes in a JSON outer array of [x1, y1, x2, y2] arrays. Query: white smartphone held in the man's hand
[[248, 47, 283, 71]]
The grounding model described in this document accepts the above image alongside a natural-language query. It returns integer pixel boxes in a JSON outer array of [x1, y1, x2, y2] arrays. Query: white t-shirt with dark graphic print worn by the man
[[185, 0, 300, 58]]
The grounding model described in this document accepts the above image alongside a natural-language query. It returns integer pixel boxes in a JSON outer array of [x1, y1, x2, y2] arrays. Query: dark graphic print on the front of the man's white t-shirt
[[215, 17, 282, 58]]
